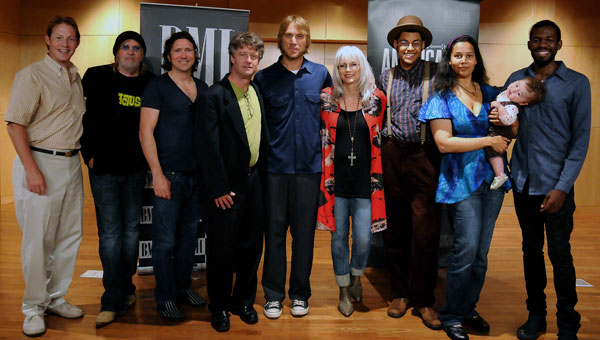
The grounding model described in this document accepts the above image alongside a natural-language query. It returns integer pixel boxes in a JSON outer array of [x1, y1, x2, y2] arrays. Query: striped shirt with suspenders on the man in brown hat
[[379, 60, 437, 143]]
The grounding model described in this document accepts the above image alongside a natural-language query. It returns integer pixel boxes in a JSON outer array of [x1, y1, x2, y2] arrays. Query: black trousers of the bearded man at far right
[[513, 183, 581, 334]]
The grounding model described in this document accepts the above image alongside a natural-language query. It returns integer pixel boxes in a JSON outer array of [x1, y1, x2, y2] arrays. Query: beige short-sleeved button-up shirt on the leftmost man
[[4, 55, 85, 151]]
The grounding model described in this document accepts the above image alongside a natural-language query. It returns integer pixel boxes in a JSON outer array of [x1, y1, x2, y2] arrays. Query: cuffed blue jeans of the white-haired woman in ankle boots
[[331, 197, 371, 287]]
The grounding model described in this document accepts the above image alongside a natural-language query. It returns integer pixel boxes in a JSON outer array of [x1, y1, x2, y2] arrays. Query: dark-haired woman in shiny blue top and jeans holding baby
[[419, 35, 516, 340]]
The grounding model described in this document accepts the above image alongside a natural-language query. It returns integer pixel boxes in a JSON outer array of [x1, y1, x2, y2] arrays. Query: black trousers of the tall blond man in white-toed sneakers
[[262, 173, 321, 301]]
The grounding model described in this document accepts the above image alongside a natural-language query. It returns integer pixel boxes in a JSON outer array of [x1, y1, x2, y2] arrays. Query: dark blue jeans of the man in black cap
[[90, 170, 146, 312]]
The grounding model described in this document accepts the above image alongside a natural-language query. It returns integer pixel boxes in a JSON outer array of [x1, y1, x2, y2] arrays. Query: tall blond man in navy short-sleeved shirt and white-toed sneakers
[[255, 15, 331, 319]]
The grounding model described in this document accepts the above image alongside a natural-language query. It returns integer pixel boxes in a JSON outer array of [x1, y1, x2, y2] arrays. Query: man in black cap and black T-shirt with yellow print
[[81, 31, 154, 327]]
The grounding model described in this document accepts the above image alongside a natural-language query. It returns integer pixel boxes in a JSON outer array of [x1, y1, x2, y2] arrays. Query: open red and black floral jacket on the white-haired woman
[[317, 87, 387, 233]]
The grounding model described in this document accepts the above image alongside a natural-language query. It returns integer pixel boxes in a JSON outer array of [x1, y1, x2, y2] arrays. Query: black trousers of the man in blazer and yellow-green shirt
[[206, 169, 264, 313]]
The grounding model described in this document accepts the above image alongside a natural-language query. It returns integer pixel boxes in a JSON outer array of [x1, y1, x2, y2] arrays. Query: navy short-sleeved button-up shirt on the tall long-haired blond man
[[254, 57, 331, 174]]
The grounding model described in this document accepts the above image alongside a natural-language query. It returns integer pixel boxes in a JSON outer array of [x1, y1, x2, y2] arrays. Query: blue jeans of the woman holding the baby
[[439, 182, 504, 327]]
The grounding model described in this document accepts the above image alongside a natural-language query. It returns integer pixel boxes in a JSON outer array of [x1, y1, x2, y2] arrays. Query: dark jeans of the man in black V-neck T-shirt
[[152, 172, 201, 305]]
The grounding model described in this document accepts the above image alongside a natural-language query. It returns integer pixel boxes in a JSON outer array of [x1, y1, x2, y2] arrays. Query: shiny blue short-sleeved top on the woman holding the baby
[[419, 84, 510, 203]]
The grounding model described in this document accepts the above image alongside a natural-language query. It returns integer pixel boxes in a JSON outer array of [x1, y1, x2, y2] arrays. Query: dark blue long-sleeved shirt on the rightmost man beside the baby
[[506, 62, 592, 195]]
